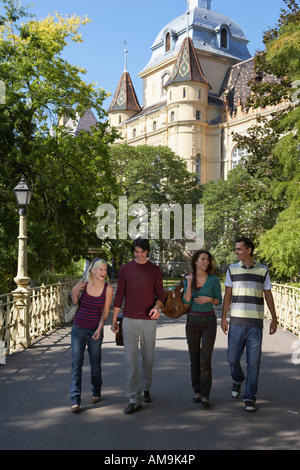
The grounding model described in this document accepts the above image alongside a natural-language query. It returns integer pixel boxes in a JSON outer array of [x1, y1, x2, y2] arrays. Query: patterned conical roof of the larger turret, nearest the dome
[[165, 37, 211, 88]]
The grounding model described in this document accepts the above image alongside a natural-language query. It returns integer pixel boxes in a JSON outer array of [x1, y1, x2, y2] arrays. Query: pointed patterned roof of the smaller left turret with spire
[[107, 70, 141, 113]]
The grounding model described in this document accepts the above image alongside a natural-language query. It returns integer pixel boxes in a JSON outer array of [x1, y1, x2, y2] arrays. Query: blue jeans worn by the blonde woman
[[70, 325, 103, 405]]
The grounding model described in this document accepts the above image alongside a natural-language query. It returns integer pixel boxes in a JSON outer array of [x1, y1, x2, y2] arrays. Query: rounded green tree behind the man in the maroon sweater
[[99, 144, 201, 265]]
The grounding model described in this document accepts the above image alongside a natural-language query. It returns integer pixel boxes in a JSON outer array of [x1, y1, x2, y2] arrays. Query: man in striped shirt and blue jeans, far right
[[221, 237, 277, 412]]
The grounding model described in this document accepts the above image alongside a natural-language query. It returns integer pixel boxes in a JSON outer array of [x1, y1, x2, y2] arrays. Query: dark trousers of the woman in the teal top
[[186, 315, 217, 399]]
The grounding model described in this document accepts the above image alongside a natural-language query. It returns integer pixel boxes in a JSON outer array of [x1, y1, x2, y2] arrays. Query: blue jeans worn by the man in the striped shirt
[[227, 325, 262, 403]]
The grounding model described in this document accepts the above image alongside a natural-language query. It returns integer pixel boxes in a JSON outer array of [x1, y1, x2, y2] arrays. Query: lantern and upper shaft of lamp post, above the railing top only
[[14, 176, 32, 291]]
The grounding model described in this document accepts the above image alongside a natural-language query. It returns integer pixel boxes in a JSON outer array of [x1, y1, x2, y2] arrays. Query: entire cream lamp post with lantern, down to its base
[[13, 176, 32, 348]]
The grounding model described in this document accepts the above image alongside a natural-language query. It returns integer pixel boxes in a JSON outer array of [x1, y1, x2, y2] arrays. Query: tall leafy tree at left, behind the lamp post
[[0, 0, 115, 288]]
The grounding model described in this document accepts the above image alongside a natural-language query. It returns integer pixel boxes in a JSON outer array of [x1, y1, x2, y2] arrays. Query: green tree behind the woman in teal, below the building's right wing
[[201, 165, 276, 265]]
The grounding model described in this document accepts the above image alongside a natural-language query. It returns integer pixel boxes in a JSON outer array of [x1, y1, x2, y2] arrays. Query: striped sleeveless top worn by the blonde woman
[[73, 282, 108, 330]]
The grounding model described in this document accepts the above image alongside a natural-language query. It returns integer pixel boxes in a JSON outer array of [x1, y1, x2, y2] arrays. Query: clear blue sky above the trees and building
[[21, 0, 286, 109]]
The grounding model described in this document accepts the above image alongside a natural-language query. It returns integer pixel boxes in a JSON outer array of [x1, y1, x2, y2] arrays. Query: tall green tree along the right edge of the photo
[[235, 0, 300, 280]]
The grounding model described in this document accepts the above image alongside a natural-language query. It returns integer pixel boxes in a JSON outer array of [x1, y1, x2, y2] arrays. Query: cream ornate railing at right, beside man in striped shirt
[[265, 283, 300, 337]]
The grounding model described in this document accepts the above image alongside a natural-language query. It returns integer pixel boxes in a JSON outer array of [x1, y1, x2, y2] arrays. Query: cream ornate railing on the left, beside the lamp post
[[0, 281, 77, 363]]
